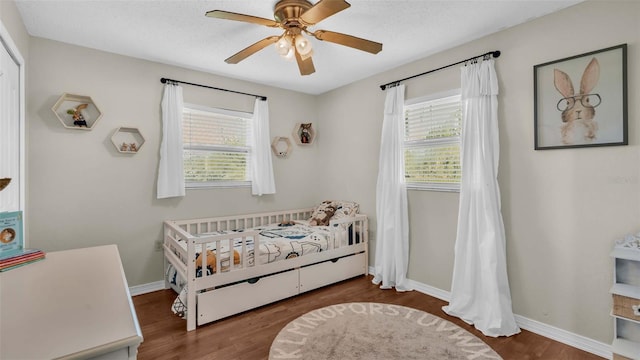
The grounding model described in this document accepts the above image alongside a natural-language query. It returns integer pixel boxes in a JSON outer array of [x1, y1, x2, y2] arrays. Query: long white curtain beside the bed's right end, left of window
[[373, 85, 412, 291]]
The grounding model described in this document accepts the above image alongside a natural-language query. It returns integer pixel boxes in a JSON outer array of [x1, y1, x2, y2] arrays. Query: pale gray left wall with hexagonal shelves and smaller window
[[27, 38, 319, 286]]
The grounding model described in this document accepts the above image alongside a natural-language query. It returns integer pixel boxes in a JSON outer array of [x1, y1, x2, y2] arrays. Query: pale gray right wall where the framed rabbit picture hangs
[[318, 1, 640, 343]]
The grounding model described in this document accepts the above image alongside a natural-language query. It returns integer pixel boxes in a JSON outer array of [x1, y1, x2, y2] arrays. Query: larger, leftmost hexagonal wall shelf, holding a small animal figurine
[[51, 93, 102, 130]]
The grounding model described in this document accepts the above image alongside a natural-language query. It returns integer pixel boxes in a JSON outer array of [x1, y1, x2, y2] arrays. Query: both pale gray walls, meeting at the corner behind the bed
[[6, 1, 640, 343]]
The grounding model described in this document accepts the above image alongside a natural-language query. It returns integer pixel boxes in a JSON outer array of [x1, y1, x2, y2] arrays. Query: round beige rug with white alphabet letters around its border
[[269, 303, 502, 360]]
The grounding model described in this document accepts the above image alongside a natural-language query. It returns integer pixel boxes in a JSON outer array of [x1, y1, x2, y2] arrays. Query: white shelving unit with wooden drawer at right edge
[[611, 237, 640, 360]]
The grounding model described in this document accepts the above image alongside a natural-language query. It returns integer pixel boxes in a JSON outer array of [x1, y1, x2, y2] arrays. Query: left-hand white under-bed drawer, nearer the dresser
[[197, 270, 298, 325]]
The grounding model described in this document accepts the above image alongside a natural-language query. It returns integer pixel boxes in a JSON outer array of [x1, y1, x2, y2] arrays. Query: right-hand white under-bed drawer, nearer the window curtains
[[300, 253, 366, 293]]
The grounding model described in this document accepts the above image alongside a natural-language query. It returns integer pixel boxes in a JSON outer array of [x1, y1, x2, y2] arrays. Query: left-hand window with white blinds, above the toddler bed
[[182, 104, 253, 188]]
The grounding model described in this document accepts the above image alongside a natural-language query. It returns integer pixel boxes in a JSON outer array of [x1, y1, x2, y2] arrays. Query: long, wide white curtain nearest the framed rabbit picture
[[443, 59, 520, 337]]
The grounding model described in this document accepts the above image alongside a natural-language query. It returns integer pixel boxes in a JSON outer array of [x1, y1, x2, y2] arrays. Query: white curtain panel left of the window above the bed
[[157, 84, 185, 199]]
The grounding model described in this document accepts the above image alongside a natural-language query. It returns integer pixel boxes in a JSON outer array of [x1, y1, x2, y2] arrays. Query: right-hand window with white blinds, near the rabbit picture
[[404, 90, 462, 191]]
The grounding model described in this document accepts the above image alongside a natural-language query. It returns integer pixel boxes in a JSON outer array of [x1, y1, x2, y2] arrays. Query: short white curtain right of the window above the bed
[[251, 99, 276, 196]]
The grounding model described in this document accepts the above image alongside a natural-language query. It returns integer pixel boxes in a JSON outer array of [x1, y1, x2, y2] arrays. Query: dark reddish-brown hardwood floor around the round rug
[[133, 276, 602, 360]]
